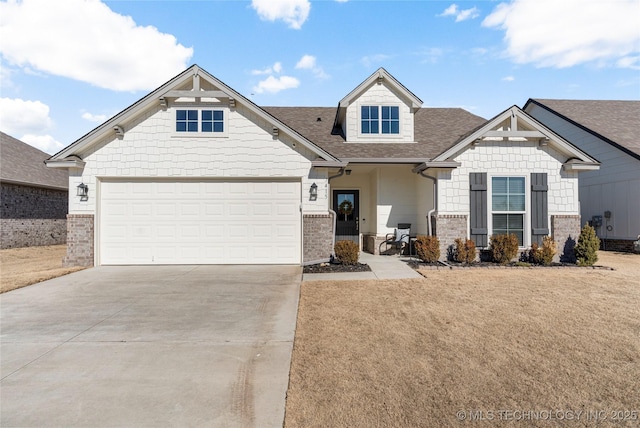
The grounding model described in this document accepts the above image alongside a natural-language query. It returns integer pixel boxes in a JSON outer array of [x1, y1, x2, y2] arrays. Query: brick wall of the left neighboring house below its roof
[[0, 183, 69, 249]]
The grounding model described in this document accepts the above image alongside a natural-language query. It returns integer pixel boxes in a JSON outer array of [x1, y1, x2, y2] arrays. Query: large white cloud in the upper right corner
[[482, 0, 640, 68]]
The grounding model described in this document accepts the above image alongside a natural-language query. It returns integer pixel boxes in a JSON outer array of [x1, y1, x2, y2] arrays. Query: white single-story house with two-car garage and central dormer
[[47, 65, 598, 265]]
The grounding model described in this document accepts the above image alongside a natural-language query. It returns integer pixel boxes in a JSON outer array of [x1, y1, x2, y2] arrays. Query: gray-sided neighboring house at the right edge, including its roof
[[524, 99, 640, 251]]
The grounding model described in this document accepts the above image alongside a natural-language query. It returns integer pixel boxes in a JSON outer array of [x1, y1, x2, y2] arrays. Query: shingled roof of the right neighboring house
[[531, 98, 640, 156]]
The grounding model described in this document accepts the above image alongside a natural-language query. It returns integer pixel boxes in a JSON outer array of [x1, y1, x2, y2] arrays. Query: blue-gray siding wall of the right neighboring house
[[527, 104, 640, 240]]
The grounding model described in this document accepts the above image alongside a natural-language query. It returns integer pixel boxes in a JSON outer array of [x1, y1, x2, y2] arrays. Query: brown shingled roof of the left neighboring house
[[0, 132, 69, 190]]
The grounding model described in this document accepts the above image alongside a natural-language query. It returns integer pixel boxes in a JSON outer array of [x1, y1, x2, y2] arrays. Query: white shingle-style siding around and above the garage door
[[69, 106, 328, 214]]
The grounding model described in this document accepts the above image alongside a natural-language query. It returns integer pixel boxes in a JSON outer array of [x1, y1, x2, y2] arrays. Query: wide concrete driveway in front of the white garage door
[[0, 266, 301, 427]]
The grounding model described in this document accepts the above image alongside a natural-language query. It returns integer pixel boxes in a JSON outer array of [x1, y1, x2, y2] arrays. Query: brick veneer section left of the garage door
[[63, 214, 94, 267]]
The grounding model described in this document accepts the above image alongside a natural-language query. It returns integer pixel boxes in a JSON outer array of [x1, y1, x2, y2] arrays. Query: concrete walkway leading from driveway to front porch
[[302, 252, 424, 281]]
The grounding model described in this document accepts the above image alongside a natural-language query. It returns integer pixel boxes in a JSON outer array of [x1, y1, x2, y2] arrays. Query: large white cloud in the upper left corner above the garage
[[0, 0, 193, 91]]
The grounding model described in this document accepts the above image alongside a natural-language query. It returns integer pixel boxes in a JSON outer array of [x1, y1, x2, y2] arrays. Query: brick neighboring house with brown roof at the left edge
[[0, 132, 69, 248]]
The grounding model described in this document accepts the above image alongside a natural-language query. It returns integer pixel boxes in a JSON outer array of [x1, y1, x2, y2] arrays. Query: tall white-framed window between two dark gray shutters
[[491, 177, 526, 247]]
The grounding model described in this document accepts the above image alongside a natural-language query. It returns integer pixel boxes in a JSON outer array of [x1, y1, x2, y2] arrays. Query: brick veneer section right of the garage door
[[302, 214, 333, 264]]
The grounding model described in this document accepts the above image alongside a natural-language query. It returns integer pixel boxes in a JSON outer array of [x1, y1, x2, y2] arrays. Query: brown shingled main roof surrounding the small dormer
[[263, 107, 486, 159]]
